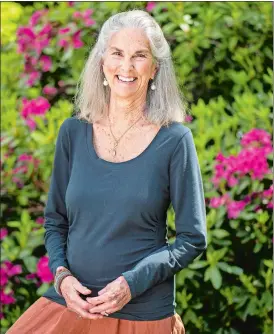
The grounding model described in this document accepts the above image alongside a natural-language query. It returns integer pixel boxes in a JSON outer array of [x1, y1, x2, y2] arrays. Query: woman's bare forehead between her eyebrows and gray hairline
[[108, 28, 150, 51]]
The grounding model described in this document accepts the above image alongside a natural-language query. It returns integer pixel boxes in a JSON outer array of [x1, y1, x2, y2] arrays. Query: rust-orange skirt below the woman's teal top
[[6, 297, 185, 334]]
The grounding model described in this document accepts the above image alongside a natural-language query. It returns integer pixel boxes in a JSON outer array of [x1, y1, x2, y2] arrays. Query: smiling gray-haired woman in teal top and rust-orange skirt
[[8, 10, 207, 334]]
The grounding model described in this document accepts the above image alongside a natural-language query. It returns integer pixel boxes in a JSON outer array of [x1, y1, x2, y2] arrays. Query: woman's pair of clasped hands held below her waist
[[61, 276, 131, 320]]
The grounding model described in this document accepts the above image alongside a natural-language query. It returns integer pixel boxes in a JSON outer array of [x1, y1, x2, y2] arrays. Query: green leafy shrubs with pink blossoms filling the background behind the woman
[[0, 2, 273, 334]]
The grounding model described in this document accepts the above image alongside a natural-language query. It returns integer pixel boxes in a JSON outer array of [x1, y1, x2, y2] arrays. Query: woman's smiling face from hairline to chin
[[102, 28, 156, 99]]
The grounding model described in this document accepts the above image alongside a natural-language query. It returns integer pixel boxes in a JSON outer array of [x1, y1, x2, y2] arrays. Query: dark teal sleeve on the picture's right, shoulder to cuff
[[122, 130, 207, 298]]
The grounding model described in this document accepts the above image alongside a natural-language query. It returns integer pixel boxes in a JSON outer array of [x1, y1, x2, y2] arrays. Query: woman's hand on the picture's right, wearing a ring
[[86, 276, 131, 314]]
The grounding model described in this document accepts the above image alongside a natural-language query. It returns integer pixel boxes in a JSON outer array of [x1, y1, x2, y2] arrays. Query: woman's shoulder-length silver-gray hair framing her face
[[74, 9, 186, 126]]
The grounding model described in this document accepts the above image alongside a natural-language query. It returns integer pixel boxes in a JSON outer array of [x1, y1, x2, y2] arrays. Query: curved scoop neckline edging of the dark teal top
[[86, 122, 165, 166]]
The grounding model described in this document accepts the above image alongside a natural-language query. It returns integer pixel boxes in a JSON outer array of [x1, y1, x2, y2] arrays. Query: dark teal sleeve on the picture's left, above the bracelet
[[44, 121, 70, 275]]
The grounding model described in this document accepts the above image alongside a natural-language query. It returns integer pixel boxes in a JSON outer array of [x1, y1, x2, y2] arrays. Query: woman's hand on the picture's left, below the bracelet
[[60, 276, 104, 320]]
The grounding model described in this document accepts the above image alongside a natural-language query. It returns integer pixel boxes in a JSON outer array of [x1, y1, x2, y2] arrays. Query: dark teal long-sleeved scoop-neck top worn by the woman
[[43, 117, 207, 321]]
